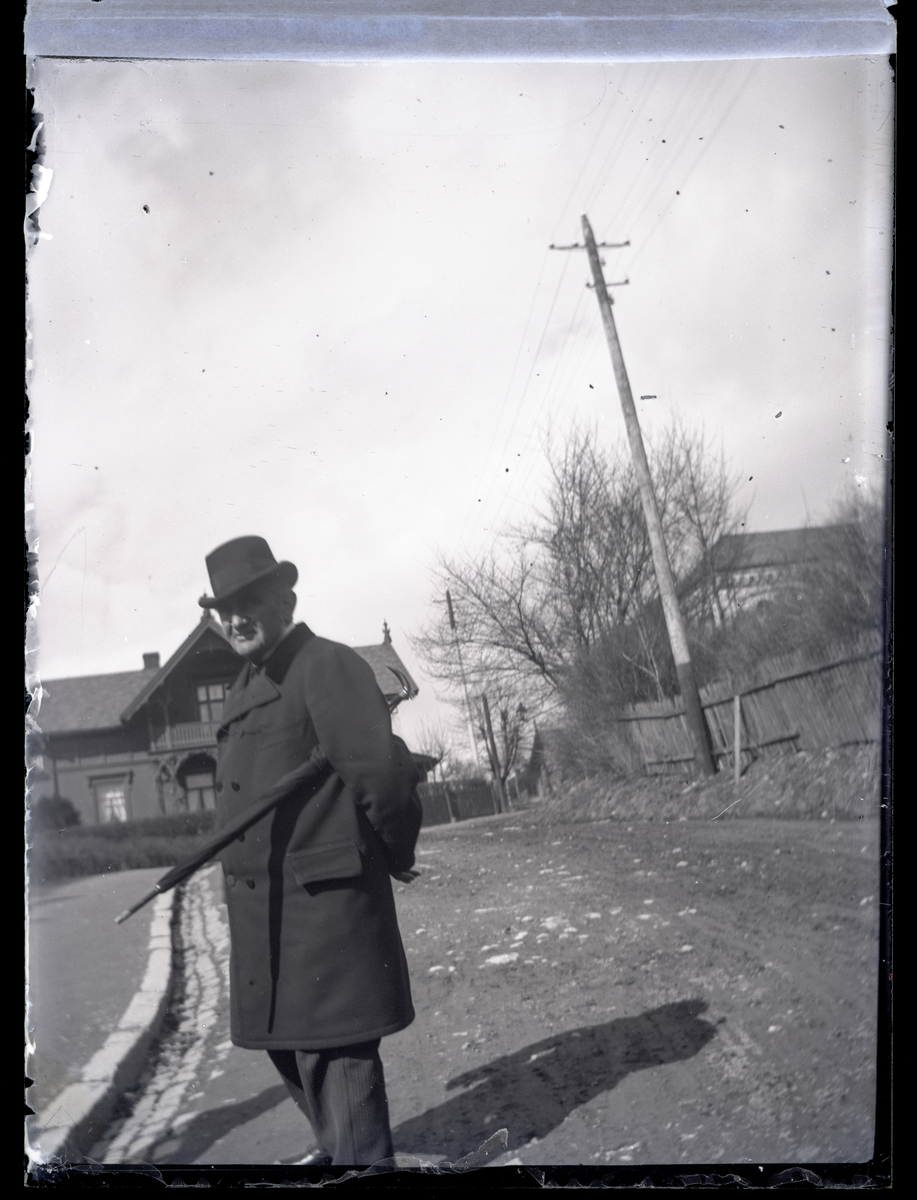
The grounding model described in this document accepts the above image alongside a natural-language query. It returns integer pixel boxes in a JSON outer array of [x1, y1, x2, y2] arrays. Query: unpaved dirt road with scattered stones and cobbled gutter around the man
[[92, 812, 879, 1165]]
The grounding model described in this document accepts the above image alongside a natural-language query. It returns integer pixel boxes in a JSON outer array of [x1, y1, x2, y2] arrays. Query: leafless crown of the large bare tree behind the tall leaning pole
[[414, 425, 741, 714]]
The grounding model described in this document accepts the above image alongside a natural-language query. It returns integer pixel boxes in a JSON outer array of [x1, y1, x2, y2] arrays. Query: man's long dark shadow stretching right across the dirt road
[[392, 1000, 715, 1162]]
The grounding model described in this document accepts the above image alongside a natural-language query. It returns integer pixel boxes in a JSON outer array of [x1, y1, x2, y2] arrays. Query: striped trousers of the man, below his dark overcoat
[[268, 1039, 394, 1166]]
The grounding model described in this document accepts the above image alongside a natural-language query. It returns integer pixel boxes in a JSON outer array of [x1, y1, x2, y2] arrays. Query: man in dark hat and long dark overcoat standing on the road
[[200, 538, 420, 1165]]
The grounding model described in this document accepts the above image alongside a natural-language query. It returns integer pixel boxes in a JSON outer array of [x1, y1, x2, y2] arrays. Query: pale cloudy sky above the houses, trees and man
[[30, 59, 892, 734]]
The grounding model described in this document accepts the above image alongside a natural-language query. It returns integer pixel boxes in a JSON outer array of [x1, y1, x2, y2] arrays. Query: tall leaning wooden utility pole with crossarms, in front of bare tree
[[555, 215, 717, 776]]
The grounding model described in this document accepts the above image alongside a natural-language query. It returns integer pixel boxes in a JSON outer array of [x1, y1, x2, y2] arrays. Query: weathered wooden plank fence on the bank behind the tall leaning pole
[[618, 638, 882, 774]]
